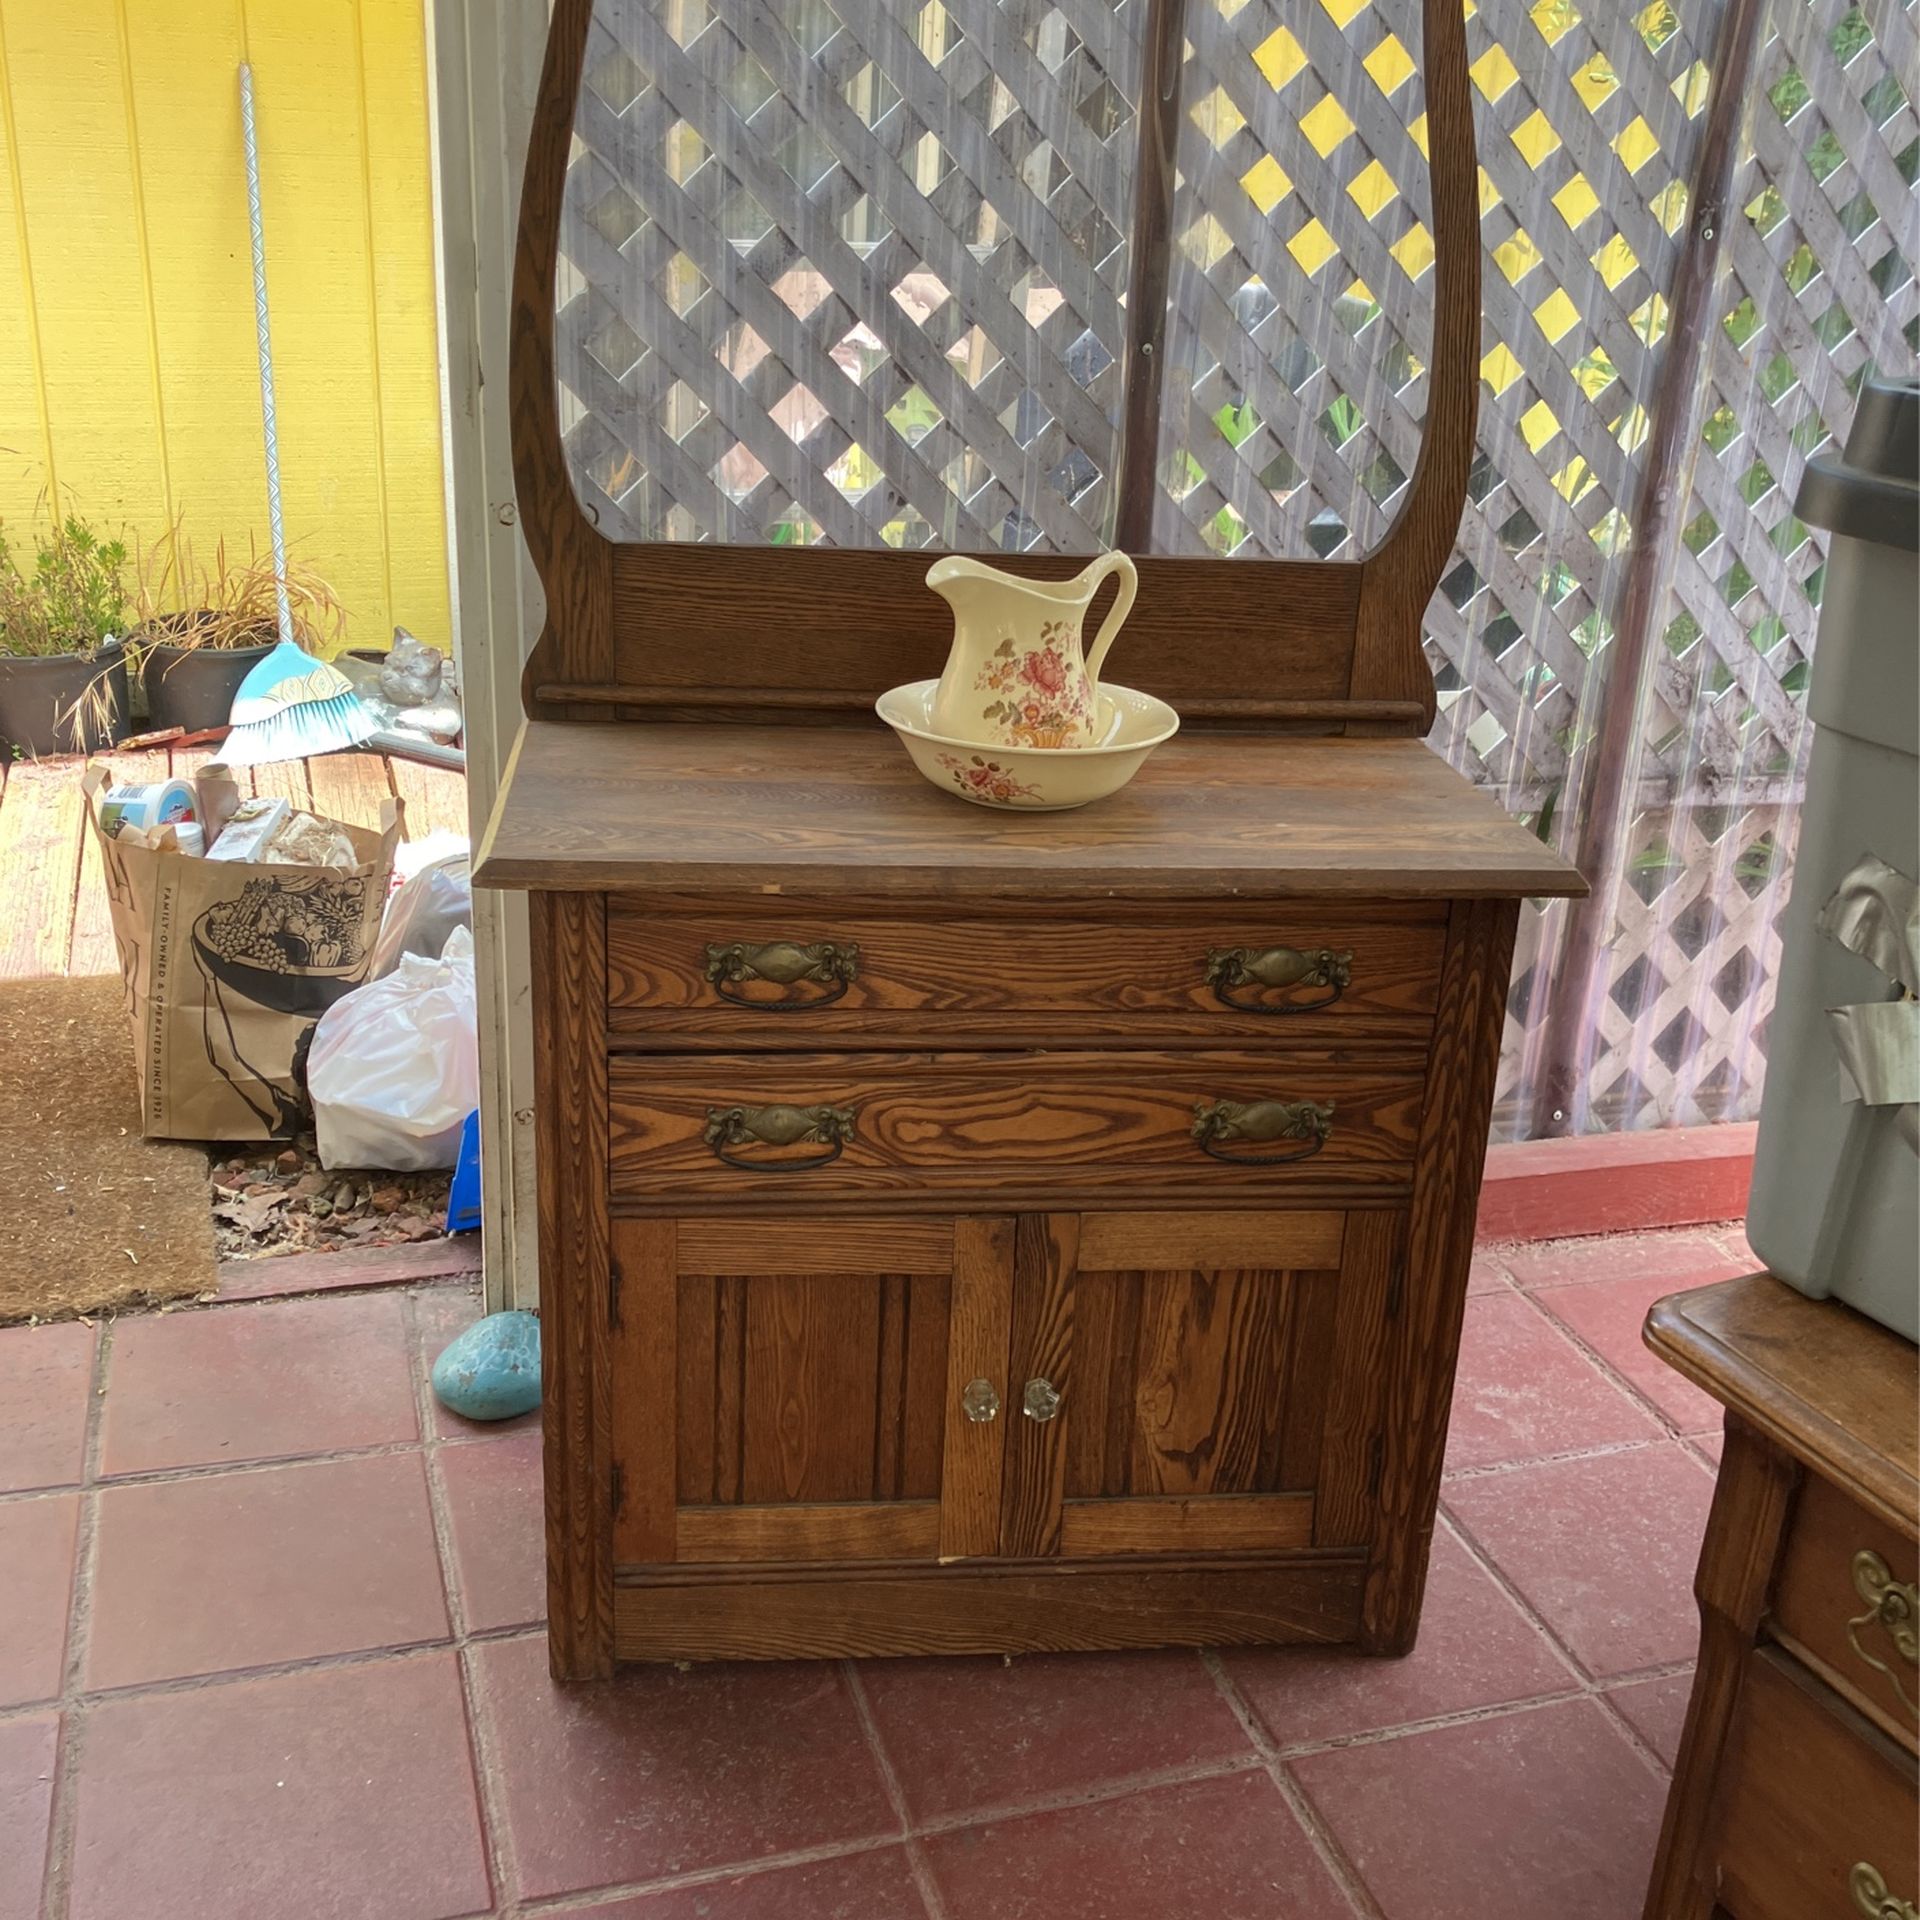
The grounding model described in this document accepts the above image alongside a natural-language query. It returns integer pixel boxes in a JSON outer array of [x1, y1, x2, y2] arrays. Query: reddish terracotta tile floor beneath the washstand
[[0, 1229, 1749, 1920]]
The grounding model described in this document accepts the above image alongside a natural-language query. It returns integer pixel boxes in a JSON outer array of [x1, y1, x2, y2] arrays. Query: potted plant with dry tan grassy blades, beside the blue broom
[[132, 520, 346, 733]]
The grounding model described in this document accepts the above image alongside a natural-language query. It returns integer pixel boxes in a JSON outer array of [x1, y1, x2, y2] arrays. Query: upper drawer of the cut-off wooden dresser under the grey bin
[[1770, 1475, 1920, 1747]]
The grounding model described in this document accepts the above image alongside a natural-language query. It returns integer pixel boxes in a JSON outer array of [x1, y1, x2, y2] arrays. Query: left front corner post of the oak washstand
[[532, 893, 612, 1680]]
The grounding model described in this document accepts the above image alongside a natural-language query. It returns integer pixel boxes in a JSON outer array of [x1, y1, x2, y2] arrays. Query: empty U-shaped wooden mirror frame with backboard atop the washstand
[[509, 0, 1480, 733]]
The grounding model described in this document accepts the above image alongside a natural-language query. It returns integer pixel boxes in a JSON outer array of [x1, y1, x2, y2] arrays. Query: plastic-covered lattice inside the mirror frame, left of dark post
[[557, 0, 1146, 553]]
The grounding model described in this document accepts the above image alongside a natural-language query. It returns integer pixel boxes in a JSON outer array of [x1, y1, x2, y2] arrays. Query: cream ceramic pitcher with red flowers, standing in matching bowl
[[927, 553, 1139, 747]]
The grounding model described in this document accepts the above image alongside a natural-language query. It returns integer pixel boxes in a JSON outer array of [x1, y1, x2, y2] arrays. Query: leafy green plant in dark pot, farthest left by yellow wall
[[0, 515, 129, 755]]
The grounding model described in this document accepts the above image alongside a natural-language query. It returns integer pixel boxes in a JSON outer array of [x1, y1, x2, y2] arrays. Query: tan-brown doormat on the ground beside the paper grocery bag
[[0, 973, 213, 1325]]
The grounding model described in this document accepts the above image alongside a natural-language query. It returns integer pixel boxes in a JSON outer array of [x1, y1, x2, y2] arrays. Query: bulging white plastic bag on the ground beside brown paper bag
[[307, 927, 480, 1173]]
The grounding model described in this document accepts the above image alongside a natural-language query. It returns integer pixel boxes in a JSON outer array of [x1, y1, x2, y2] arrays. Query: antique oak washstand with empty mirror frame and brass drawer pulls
[[476, 0, 1580, 1678]]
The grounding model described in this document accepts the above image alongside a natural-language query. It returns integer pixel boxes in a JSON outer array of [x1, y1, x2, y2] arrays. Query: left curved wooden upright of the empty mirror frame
[[507, 0, 612, 718]]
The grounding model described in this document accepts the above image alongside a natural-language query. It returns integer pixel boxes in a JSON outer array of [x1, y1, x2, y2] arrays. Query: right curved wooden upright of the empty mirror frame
[[1348, 0, 1480, 733]]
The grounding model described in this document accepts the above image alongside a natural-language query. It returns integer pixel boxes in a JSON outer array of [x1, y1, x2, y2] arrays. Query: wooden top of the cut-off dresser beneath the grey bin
[[1645, 1273, 1920, 1532]]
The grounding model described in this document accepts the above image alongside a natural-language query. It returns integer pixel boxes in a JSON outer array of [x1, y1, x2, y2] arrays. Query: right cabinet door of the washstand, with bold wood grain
[[1002, 1212, 1398, 1557]]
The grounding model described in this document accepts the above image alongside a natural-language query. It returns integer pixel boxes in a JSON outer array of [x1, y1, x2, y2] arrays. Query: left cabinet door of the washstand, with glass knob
[[609, 1217, 1012, 1565]]
